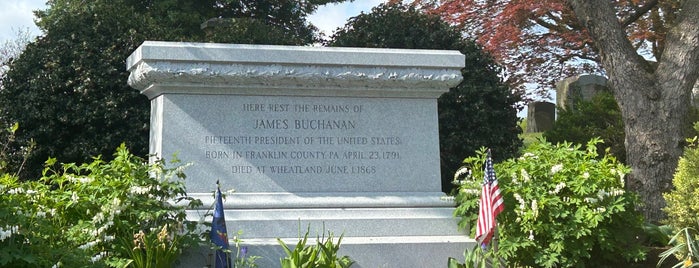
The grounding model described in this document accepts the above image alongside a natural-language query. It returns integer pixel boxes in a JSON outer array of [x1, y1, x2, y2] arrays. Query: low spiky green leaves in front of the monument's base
[[277, 226, 354, 268]]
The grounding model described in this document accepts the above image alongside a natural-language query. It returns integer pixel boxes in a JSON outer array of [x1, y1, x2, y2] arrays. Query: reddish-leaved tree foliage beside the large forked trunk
[[413, 0, 678, 97]]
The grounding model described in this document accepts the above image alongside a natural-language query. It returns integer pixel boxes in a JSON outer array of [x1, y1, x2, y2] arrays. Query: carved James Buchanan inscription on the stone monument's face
[[201, 100, 405, 176]]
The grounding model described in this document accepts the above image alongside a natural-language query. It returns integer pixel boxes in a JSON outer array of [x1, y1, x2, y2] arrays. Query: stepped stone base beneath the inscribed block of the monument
[[181, 192, 475, 268]]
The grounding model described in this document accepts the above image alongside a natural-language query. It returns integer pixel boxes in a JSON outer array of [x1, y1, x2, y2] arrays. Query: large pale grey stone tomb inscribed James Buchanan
[[127, 42, 473, 267]]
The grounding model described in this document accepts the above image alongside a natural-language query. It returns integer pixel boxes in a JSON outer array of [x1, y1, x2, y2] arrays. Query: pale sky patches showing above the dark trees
[[0, 0, 385, 44]]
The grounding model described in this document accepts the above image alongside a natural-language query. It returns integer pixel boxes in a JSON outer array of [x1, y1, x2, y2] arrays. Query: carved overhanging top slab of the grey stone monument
[[127, 41, 465, 98]]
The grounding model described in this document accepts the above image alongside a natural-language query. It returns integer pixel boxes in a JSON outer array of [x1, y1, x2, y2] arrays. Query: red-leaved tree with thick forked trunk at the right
[[418, 0, 699, 222]]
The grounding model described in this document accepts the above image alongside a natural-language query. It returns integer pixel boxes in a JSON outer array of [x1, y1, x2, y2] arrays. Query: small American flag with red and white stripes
[[476, 149, 505, 245]]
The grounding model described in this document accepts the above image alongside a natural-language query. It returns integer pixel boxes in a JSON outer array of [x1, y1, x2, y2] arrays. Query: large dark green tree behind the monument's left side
[[0, 0, 344, 179]]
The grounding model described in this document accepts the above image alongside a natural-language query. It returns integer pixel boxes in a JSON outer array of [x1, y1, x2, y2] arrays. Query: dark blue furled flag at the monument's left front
[[209, 182, 230, 268]]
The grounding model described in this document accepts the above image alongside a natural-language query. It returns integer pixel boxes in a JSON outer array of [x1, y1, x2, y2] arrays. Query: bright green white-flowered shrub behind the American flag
[[455, 139, 644, 267]]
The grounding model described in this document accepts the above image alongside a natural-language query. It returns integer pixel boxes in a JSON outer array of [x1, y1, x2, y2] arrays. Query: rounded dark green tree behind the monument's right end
[[329, 4, 522, 192]]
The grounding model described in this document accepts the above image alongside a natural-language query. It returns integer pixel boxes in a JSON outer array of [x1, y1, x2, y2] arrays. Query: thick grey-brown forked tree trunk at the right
[[568, 0, 699, 223]]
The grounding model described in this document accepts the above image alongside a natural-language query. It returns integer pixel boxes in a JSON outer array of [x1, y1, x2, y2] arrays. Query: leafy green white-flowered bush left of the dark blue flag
[[0, 145, 202, 267]]
